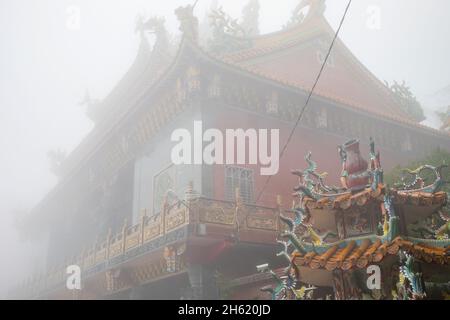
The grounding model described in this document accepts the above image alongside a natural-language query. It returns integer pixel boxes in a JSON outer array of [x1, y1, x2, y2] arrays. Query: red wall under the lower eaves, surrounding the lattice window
[[204, 108, 448, 207]]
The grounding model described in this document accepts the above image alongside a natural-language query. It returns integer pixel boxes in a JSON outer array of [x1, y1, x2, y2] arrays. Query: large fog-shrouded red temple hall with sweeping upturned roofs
[[11, 0, 450, 299]]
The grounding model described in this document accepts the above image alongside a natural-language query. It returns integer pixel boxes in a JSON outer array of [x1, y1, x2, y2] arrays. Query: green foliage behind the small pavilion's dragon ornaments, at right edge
[[384, 149, 450, 193]]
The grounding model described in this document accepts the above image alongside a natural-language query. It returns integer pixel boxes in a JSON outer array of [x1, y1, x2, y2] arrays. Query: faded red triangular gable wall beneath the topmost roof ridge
[[241, 43, 401, 120]]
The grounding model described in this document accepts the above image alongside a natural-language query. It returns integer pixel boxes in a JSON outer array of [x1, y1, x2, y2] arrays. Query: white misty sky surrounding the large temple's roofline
[[0, 0, 450, 298]]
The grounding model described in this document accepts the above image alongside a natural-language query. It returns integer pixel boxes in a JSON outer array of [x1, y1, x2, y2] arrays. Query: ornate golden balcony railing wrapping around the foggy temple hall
[[11, 192, 280, 297]]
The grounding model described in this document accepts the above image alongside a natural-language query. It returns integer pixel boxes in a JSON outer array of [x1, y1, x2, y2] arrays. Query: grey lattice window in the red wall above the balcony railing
[[225, 167, 254, 203]]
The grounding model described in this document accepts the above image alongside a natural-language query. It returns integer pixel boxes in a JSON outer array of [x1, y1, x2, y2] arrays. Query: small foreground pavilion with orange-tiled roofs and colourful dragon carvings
[[262, 139, 450, 300]]
